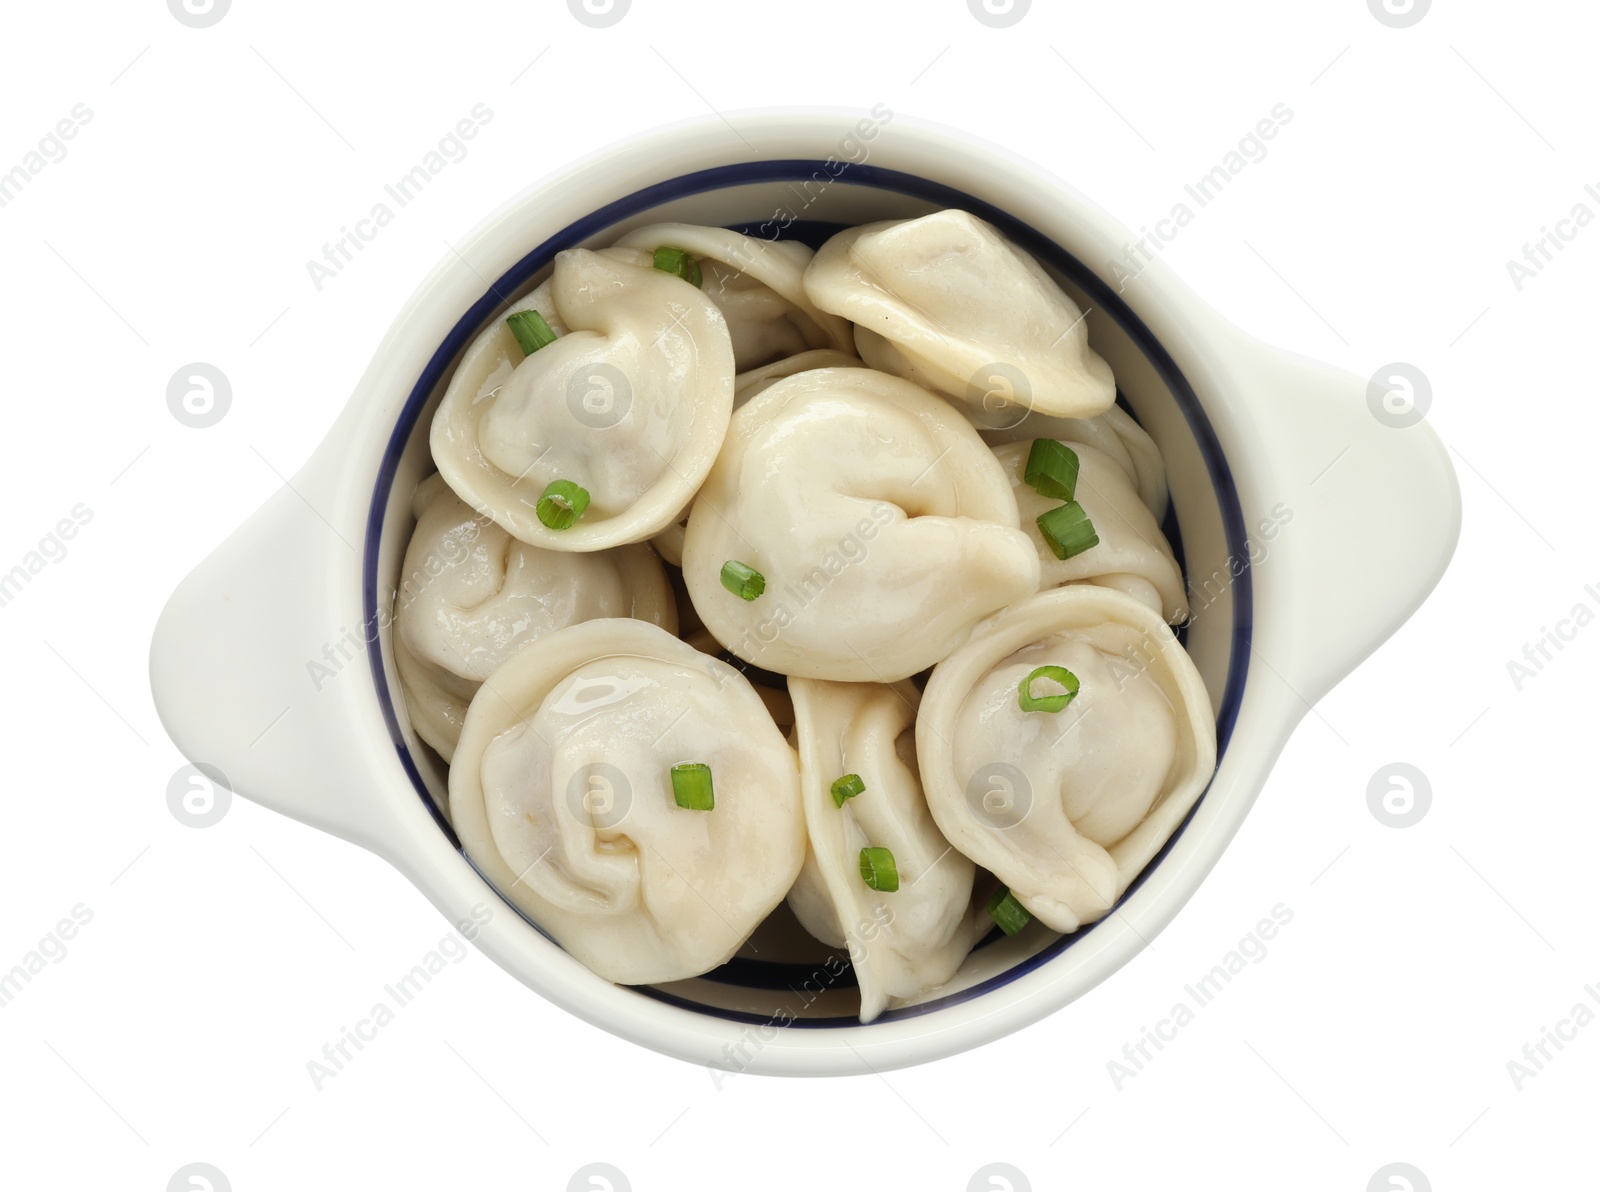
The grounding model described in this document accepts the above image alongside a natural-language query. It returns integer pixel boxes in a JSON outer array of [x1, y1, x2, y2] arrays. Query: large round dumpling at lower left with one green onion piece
[[450, 621, 805, 984]]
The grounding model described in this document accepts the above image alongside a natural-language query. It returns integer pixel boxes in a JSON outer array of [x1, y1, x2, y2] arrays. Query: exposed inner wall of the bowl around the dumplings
[[363, 160, 1250, 1027]]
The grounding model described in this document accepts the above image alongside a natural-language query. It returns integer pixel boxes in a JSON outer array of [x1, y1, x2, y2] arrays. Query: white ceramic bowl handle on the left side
[[150, 470, 406, 854]]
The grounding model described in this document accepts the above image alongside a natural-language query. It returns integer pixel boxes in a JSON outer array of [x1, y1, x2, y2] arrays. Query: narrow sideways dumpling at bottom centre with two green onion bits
[[789, 678, 976, 1022]]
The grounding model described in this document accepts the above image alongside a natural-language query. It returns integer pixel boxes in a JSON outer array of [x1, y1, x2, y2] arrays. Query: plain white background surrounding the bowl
[[0, 0, 1600, 1192]]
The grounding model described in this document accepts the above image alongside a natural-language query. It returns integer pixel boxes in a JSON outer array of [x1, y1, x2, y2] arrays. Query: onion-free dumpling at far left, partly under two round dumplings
[[395, 475, 678, 762]]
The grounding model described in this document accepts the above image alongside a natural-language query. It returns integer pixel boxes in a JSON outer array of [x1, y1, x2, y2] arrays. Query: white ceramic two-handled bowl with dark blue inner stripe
[[150, 107, 1459, 1074]]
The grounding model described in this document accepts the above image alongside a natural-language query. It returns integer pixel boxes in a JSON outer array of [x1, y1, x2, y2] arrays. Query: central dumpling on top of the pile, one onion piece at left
[[683, 368, 1038, 683]]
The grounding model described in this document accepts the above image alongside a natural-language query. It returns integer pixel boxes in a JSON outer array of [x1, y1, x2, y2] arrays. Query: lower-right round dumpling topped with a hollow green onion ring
[[917, 586, 1216, 931]]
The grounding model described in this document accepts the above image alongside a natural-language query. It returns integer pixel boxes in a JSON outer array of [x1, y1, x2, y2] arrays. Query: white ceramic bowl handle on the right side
[[1209, 336, 1461, 707]]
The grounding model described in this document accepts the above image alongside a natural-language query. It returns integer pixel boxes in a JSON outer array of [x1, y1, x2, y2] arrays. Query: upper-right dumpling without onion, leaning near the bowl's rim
[[805, 211, 1117, 418]]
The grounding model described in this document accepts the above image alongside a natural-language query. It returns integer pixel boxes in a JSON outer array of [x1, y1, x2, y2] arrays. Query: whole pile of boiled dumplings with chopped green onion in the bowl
[[395, 210, 1216, 1022]]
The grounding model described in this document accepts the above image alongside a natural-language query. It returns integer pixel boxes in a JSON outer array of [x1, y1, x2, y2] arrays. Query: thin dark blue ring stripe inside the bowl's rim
[[362, 158, 1253, 1029]]
